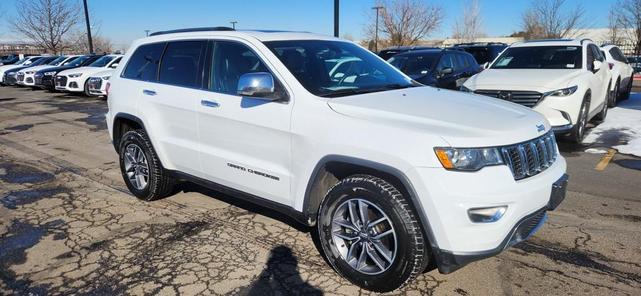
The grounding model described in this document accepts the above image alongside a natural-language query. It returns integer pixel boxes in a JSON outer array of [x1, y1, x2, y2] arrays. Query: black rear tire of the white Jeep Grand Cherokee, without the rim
[[118, 130, 175, 201]]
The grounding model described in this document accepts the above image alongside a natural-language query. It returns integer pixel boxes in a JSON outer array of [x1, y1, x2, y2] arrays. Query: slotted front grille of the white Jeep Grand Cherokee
[[500, 132, 557, 180]]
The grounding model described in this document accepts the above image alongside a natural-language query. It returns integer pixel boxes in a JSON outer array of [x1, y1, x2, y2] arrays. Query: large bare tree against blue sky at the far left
[[10, 0, 80, 53]]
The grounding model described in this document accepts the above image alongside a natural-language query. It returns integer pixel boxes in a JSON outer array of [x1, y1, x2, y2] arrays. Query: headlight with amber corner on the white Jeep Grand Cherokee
[[434, 148, 503, 171]]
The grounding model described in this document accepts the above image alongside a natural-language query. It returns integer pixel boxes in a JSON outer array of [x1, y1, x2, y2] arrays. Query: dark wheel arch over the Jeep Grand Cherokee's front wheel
[[303, 155, 440, 255]]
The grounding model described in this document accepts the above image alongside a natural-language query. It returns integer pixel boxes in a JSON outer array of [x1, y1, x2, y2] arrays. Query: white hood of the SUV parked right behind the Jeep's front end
[[464, 69, 582, 92]]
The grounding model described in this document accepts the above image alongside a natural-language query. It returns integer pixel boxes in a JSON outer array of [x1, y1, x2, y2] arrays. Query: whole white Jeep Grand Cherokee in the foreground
[[106, 28, 567, 291]]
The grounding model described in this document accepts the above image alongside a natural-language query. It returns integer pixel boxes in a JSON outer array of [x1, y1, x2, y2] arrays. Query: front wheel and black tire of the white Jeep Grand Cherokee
[[317, 175, 429, 292]]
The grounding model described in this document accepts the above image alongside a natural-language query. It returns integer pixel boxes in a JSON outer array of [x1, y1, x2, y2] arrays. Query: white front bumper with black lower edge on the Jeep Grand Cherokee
[[406, 155, 566, 272]]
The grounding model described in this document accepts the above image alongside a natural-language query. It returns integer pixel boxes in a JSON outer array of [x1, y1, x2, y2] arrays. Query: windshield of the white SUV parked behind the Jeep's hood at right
[[491, 46, 583, 69]]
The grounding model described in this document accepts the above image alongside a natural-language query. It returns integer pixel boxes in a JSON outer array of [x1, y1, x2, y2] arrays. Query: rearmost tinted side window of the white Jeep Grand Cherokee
[[122, 43, 165, 81]]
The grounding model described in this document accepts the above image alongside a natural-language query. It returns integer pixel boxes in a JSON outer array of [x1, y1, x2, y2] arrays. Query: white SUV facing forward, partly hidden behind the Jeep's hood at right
[[462, 39, 612, 143]]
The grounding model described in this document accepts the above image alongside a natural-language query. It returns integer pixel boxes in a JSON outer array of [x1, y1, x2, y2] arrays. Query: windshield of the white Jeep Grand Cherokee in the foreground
[[265, 40, 415, 97]]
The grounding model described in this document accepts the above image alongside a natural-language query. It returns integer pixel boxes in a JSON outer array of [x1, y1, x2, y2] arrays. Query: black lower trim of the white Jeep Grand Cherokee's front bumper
[[434, 174, 568, 273]]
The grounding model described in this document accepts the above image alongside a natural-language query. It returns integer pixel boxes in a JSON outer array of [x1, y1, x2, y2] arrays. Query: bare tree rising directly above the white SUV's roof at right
[[522, 0, 585, 39]]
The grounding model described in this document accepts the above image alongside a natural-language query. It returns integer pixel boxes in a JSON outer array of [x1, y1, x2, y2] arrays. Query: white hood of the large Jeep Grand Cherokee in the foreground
[[328, 87, 550, 147]]
